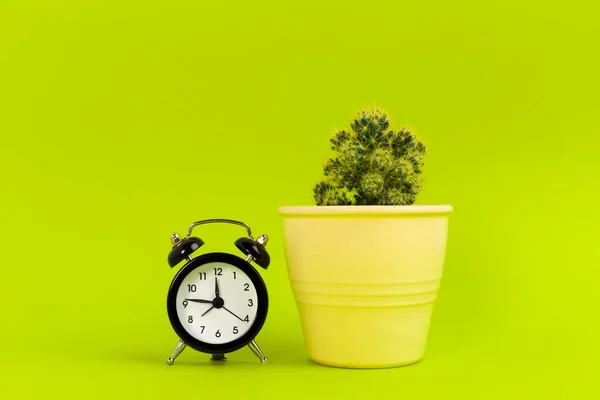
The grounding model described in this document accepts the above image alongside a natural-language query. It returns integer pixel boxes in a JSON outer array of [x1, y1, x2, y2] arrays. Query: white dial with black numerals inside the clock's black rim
[[176, 262, 258, 344]]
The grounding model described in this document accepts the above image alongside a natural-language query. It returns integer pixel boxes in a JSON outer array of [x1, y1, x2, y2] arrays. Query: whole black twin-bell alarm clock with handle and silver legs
[[162, 219, 271, 365]]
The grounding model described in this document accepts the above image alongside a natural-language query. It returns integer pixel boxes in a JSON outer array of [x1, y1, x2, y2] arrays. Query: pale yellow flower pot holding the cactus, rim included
[[279, 205, 452, 368]]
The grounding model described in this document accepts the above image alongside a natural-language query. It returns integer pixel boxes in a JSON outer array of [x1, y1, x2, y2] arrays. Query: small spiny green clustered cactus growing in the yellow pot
[[313, 109, 426, 206]]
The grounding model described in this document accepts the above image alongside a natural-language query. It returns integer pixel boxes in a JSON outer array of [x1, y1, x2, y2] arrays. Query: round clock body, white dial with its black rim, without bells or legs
[[167, 253, 268, 354]]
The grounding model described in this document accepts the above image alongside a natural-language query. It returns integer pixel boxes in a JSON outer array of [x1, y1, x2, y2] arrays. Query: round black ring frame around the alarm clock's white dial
[[167, 252, 269, 354]]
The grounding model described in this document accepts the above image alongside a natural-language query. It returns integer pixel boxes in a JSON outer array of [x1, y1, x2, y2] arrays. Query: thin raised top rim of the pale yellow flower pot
[[278, 204, 453, 216]]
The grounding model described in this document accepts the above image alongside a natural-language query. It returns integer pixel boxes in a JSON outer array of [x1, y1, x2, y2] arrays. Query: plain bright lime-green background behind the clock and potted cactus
[[0, 0, 600, 399]]
